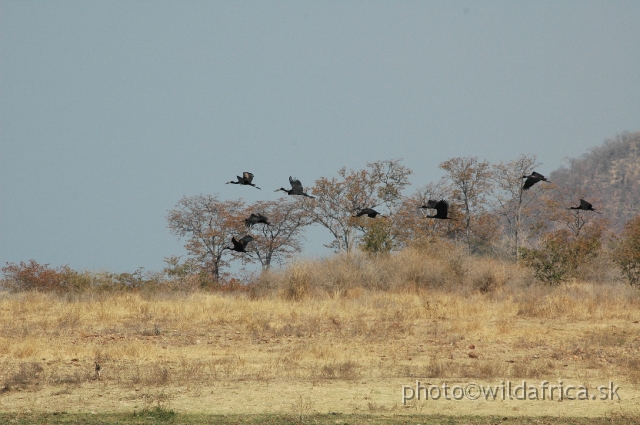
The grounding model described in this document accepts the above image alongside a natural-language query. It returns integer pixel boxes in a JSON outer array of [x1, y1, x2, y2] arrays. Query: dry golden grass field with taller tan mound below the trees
[[0, 250, 640, 416]]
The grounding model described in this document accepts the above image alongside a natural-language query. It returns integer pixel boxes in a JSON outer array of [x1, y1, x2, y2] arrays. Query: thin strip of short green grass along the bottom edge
[[0, 414, 640, 425]]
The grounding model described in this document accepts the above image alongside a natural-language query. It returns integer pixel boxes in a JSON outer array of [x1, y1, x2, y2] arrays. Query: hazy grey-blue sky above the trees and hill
[[0, 0, 640, 272]]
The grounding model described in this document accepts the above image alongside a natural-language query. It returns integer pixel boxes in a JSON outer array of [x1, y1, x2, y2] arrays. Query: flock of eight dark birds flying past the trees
[[224, 171, 602, 252]]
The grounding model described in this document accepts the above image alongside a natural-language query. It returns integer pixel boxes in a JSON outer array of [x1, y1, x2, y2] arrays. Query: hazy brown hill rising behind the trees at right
[[549, 131, 640, 231]]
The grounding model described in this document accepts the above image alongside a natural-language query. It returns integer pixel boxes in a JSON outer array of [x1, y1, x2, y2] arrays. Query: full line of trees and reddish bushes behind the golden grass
[[0, 155, 640, 291]]
